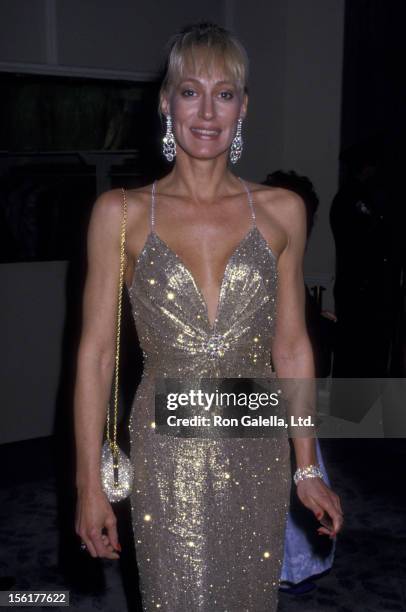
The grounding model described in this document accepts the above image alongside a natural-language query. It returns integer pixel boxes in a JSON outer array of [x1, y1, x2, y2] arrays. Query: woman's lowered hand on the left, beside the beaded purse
[[75, 489, 121, 559]]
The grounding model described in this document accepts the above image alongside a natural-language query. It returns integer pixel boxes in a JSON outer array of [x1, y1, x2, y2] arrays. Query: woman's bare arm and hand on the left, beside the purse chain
[[74, 190, 126, 559]]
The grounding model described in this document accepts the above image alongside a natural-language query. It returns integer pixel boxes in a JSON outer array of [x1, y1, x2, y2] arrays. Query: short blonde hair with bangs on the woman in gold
[[159, 22, 248, 109]]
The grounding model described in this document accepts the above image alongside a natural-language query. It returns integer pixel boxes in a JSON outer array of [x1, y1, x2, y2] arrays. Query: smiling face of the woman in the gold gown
[[162, 58, 248, 159]]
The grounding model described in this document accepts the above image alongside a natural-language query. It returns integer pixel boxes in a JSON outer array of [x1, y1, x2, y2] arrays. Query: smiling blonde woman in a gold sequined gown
[[75, 24, 342, 612]]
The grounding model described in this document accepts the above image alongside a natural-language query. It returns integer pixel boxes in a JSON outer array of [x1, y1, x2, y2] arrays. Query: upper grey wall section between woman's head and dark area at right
[[234, 0, 344, 308]]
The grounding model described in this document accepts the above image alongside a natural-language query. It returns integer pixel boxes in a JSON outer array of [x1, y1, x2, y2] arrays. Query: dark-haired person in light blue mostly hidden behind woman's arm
[[264, 170, 335, 595]]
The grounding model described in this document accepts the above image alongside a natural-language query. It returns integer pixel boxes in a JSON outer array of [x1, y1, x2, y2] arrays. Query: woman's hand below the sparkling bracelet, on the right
[[296, 477, 344, 538]]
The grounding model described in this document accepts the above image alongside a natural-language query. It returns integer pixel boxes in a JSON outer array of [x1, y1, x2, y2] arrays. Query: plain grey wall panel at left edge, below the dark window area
[[0, 261, 67, 444]]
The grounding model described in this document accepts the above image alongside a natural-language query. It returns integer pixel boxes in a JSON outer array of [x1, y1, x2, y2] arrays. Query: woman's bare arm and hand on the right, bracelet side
[[272, 190, 343, 537]]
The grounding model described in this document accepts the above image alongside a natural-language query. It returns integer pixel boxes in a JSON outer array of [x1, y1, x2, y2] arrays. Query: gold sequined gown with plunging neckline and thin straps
[[129, 183, 291, 612]]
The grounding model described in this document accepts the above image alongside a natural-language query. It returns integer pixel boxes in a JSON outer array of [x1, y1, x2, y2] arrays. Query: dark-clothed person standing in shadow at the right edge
[[330, 141, 406, 437]]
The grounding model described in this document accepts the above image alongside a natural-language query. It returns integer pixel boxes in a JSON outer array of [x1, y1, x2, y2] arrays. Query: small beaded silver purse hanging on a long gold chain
[[100, 189, 134, 502]]
